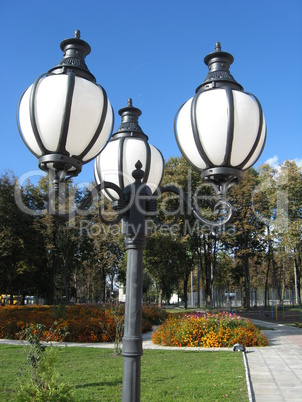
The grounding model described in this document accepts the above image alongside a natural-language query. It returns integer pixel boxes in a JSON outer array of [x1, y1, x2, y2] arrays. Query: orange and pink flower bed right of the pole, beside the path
[[152, 313, 268, 348]]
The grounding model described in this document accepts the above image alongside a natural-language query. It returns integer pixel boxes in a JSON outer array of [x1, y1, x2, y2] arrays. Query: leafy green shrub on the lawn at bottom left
[[17, 323, 75, 402]]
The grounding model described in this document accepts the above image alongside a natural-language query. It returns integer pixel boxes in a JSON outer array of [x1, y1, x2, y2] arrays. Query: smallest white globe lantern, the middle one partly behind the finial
[[94, 99, 164, 202]]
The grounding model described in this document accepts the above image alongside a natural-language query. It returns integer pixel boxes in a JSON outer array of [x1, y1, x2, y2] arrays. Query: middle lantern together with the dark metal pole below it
[[94, 99, 164, 402]]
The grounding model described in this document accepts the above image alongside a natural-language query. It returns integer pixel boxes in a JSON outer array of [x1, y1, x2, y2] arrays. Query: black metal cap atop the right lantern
[[196, 42, 243, 93]]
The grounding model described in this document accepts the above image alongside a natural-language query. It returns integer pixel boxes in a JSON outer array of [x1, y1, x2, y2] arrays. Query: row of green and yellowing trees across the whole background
[[0, 157, 302, 306]]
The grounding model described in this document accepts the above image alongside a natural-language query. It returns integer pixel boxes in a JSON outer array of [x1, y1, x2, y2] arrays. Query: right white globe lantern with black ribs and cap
[[174, 42, 266, 181]]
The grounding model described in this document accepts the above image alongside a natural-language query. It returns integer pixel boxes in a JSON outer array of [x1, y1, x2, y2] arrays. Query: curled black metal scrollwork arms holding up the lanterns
[[48, 162, 238, 229]]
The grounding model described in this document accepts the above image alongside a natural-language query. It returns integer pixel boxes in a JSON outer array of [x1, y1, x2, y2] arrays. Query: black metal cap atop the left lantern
[[48, 30, 96, 82]]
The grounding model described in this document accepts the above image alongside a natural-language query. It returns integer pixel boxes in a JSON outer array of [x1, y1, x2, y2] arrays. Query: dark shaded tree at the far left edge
[[0, 173, 46, 301]]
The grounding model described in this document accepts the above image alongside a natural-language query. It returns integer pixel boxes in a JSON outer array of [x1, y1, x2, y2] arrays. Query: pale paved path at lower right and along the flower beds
[[0, 319, 302, 402]]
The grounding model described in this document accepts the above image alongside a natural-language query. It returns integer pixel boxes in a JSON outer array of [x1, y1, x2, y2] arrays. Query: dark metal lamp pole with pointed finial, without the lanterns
[[122, 163, 150, 402]]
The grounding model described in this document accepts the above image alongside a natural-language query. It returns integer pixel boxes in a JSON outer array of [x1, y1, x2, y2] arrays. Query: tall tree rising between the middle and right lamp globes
[[159, 157, 215, 305]]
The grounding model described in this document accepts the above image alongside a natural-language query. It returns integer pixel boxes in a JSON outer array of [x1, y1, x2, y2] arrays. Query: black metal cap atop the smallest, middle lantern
[[112, 98, 148, 141]]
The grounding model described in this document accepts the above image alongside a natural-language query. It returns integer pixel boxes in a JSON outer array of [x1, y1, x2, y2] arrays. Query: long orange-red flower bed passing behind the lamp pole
[[0, 305, 165, 342]]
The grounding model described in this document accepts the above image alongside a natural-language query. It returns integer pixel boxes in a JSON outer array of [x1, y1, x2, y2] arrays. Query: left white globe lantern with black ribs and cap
[[17, 31, 114, 182]]
